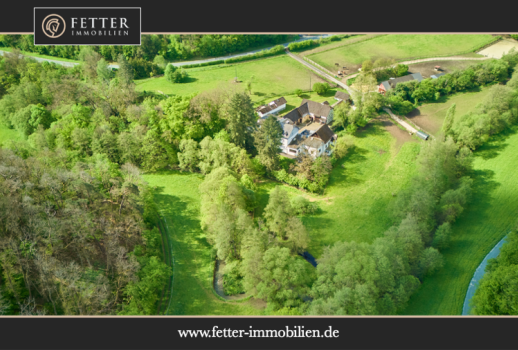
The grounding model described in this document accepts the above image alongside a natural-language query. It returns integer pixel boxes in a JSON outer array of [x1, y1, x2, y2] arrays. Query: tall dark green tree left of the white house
[[225, 92, 257, 152]]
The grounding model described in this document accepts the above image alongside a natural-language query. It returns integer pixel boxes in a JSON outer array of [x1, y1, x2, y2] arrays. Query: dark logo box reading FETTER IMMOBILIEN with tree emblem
[[34, 7, 141, 45]]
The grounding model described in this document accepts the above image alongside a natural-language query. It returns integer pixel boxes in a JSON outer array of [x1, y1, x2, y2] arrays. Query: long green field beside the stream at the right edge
[[402, 127, 518, 315]]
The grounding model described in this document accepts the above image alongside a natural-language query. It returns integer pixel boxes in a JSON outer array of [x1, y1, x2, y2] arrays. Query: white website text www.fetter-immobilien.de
[[178, 326, 339, 338]]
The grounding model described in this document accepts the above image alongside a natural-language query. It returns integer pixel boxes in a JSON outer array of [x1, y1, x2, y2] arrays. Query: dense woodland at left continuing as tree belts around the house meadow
[[0, 41, 518, 315]]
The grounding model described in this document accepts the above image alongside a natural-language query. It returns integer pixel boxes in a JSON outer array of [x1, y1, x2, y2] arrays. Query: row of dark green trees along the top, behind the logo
[[0, 34, 297, 62]]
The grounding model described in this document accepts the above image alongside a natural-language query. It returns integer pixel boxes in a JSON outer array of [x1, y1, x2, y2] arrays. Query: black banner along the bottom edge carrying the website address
[[0, 317, 518, 349]]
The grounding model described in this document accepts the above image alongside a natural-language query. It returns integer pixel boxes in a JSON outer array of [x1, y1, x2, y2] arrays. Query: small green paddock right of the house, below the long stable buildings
[[406, 86, 496, 136]]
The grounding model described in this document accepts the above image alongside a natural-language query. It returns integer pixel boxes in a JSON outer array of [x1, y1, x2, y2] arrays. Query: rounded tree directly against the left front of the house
[[253, 115, 283, 171]]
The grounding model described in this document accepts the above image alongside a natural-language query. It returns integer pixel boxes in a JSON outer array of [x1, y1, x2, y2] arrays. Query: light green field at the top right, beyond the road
[[308, 34, 492, 74]]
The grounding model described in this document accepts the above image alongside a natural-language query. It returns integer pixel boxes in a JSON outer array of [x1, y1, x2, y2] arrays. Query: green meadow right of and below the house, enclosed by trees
[[256, 121, 420, 258]]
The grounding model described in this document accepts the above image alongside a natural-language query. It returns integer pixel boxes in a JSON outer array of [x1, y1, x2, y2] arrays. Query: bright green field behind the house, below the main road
[[135, 55, 330, 102]]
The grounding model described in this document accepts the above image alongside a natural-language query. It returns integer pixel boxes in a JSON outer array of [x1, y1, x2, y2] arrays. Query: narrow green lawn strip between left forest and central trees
[[144, 171, 263, 315]]
